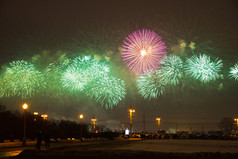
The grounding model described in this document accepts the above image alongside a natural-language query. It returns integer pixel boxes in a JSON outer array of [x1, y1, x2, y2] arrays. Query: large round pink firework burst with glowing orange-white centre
[[121, 29, 166, 74]]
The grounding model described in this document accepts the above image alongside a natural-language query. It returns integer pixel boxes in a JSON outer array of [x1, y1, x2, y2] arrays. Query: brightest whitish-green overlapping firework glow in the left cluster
[[62, 56, 109, 91]]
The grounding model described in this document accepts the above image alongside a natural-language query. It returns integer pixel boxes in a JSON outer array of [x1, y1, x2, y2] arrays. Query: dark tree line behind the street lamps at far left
[[0, 108, 89, 142]]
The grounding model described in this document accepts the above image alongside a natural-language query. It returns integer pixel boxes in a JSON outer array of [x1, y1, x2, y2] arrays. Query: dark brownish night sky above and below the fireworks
[[0, 0, 238, 131]]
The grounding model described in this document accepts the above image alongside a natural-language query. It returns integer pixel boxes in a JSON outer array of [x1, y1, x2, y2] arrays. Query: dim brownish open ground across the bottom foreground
[[1, 140, 238, 159]]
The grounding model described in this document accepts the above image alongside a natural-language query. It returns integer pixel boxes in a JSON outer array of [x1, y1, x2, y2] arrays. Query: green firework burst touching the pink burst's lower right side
[[158, 55, 183, 85]]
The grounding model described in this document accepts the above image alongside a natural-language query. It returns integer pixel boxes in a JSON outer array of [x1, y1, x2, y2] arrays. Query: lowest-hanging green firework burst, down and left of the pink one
[[87, 76, 126, 109]]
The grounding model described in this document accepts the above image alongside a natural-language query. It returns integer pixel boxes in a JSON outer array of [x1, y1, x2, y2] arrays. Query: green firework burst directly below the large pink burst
[[136, 71, 165, 100]]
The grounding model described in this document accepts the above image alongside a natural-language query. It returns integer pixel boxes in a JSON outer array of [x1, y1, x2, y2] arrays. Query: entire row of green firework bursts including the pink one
[[0, 26, 238, 109]]
